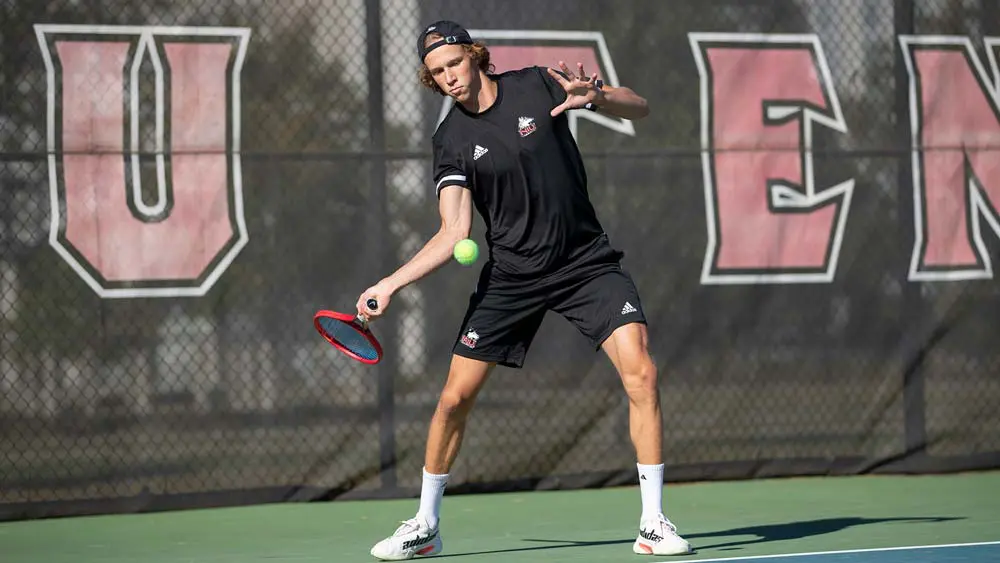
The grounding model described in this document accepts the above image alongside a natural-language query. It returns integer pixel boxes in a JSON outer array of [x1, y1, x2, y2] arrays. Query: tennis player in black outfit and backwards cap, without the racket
[[357, 21, 691, 560]]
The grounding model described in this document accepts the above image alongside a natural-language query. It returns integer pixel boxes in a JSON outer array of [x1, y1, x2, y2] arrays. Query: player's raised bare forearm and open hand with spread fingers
[[548, 61, 649, 120]]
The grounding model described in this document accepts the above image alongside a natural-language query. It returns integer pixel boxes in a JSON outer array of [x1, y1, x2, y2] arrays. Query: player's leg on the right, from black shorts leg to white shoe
[[553, 269, 691, 555]]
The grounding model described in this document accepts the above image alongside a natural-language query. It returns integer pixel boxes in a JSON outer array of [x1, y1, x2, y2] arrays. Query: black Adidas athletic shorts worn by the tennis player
[[453, 236, 646, 368]]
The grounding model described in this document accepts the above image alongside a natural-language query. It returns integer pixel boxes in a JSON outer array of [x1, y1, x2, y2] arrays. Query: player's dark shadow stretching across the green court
[[434, 517, 964, 559]]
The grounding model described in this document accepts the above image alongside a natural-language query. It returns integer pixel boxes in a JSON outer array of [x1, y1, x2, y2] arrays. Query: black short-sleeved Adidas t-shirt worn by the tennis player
[[432, 66, 620, 279]]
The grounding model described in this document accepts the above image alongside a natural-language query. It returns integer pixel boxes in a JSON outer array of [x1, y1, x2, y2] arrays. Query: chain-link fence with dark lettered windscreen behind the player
[[0, 0, 1000, 519]]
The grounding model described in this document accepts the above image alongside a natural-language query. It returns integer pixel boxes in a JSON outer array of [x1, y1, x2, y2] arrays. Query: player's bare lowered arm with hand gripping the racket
[[357, 184, 472, 317]]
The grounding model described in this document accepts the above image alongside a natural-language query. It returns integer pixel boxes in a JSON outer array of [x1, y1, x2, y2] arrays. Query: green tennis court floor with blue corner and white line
[[0, 472, 1000, 563]]
